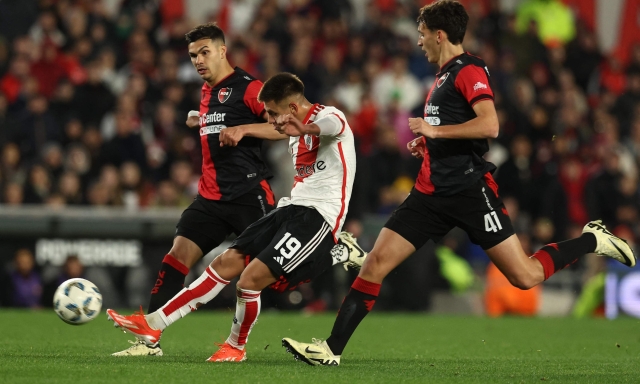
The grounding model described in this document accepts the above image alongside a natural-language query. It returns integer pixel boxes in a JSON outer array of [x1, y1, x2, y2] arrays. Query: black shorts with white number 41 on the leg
[[384, 173, 514, 249]]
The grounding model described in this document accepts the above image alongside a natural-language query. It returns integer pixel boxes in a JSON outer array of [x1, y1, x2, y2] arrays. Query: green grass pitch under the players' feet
[[0, 309, 640, 384]]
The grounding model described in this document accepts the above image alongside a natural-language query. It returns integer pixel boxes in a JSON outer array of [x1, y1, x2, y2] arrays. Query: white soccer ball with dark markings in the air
[[53, 278, 102, 325]]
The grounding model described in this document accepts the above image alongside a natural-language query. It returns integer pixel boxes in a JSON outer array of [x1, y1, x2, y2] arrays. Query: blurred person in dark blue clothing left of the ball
[[9, 248, 42, 308]]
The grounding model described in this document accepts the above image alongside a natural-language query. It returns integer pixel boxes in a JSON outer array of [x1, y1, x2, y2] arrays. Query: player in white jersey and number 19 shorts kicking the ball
[[107, 73, 366, 362]]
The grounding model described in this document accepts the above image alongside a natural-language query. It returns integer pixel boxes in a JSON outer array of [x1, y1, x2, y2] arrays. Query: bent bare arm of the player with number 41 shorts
[[409, 100, 500, 139]]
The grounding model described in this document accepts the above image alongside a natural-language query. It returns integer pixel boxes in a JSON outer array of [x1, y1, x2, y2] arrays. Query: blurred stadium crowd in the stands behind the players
[[0, 0, 640, 312]]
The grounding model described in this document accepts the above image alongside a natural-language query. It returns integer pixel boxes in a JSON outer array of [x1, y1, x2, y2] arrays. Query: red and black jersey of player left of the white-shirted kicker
[[198, 67, 272, 200]]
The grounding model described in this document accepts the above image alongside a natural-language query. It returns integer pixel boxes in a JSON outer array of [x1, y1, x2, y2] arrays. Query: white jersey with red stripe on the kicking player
[[278, 104, 356, 238]]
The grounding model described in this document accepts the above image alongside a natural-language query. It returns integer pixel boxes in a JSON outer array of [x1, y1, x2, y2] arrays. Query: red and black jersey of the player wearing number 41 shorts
[[416, 53, 496, 196]]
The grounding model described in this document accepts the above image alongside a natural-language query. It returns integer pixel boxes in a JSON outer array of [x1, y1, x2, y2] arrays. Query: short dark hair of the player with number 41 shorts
[[418, 0, 469, 45]]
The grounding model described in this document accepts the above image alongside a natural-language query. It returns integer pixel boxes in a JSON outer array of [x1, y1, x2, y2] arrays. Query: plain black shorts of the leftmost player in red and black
[[176, 183, 275, 255]]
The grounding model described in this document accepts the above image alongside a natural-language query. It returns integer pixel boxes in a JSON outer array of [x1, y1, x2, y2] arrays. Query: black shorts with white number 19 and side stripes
[[230, 205, 340, 292]]
